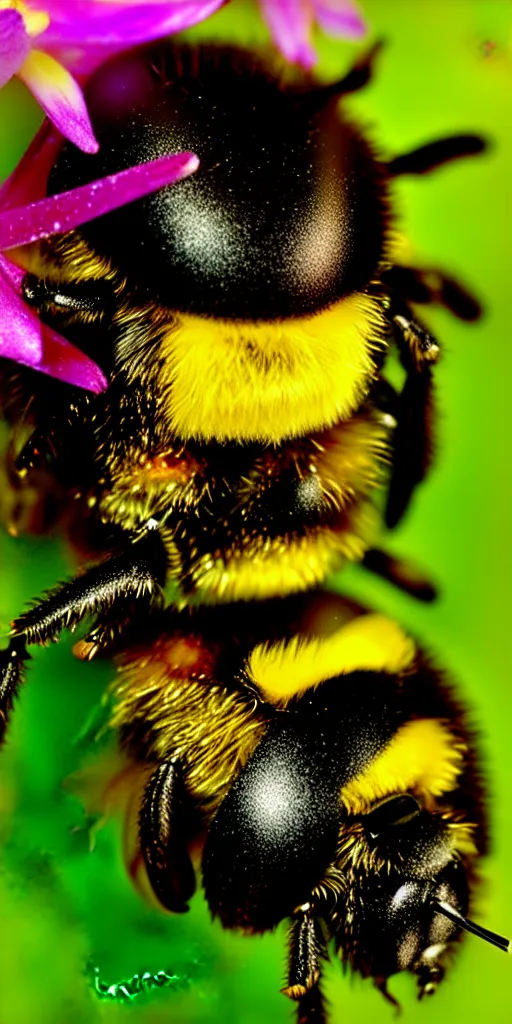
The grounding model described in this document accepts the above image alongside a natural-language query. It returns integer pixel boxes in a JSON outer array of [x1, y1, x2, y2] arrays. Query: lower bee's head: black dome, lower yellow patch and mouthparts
[[198, 651, 495, 997]]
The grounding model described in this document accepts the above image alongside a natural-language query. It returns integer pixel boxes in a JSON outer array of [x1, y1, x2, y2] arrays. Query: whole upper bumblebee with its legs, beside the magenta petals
[[0, 44, 483, 721]]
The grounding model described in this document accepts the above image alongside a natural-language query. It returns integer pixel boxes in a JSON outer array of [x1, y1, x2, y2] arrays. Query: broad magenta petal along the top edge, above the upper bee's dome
[[38, 0, 226, 74]]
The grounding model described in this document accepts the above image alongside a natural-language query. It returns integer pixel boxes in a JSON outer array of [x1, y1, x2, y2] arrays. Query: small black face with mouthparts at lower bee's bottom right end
[[333, 794, 475, 996]]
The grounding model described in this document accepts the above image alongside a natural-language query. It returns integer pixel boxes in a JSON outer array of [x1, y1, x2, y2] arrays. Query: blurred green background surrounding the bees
[[0, 0, 512, 1024]]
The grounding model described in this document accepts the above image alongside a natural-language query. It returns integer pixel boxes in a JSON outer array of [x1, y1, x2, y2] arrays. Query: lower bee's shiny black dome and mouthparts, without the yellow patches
[[197, 704, 478, 997]]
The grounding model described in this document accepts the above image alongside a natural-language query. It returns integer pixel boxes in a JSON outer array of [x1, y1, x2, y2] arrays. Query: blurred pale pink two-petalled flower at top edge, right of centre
[[260, 0, 366, 69]]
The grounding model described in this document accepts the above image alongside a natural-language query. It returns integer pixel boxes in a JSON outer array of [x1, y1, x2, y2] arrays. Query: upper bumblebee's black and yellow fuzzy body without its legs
[[8, 46, 390, 600]]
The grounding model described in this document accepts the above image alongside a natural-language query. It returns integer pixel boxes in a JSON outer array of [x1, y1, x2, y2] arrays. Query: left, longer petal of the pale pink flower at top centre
[[260, 0, 316, 69]]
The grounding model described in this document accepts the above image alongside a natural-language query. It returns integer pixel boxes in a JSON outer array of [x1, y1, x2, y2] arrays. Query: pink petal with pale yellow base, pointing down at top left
[[17, 50, 99, 153]]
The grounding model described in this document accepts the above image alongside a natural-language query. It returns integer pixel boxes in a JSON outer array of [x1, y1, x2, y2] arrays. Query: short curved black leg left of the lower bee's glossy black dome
[[139, 761, 196, 913]]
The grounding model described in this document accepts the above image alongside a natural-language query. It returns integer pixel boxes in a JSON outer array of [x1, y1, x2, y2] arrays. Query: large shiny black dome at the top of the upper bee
[[51, 46, 384, 319]]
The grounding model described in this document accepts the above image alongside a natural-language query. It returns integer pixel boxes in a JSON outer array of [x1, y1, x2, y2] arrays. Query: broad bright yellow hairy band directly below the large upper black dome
[[30, 232, 387, 443]]
